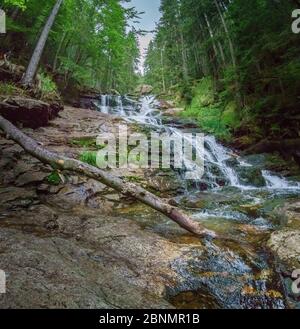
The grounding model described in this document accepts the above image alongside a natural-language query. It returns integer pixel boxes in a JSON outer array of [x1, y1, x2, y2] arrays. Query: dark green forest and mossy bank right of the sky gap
[[146, 0, 300, 147]]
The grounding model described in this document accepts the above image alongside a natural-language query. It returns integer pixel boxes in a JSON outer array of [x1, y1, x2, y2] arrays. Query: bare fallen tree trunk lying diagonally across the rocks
[[0, 115, 216, 238]]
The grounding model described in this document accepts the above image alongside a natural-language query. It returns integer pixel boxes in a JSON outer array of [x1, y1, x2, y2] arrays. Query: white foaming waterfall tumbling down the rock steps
[[98, 95, 300, 190]]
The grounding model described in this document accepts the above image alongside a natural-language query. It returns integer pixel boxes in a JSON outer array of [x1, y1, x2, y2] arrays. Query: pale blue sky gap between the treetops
[[127, 0, 161, 71]]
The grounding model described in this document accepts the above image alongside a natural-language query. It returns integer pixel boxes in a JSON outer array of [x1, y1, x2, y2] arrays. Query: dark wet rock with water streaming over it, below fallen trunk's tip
[[168, 243, 285, 309]]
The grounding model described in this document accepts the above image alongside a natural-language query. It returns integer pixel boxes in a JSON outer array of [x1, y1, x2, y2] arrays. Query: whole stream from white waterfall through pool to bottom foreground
[[98, 96, 300, 308]]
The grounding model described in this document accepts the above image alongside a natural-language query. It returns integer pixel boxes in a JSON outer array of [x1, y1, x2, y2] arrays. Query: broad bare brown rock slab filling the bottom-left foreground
[[0, 205, 191, 308]]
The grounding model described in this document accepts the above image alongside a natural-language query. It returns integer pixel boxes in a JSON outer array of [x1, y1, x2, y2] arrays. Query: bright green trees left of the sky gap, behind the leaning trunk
[[0, 0, 139, 93]]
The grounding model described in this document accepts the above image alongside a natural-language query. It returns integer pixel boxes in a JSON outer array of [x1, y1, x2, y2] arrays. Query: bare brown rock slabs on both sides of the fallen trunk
[[0, 104, 200, 309]]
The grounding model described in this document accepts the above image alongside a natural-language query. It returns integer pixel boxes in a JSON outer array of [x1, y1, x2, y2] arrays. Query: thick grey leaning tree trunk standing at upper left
[[21, 0, 63, 86]]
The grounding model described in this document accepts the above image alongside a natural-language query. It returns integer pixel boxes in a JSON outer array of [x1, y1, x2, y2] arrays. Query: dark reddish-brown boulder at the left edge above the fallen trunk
[[0, 96, 63, 128]]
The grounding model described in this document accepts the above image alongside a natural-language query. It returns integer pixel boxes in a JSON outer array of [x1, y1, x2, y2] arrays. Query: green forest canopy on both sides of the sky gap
[[1, 0, 300, 145]]
